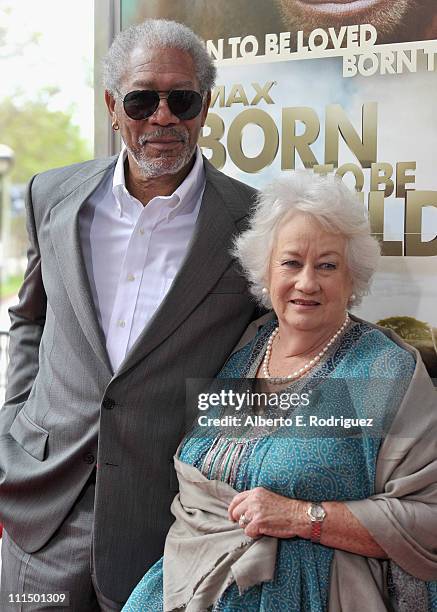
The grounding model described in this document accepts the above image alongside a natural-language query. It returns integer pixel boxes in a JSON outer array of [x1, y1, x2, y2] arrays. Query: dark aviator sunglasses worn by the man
[[123, 89, 203, 121]]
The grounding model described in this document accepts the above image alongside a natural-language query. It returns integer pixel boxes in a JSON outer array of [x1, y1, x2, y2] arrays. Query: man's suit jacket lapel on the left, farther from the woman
[[50, 159, 115, 374]]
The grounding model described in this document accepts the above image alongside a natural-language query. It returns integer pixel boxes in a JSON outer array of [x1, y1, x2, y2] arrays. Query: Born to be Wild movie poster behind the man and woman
[[121, 0, 437, 378]]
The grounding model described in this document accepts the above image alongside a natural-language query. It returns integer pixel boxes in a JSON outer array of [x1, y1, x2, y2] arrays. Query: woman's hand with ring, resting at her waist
[[228, 487, 311, 538]]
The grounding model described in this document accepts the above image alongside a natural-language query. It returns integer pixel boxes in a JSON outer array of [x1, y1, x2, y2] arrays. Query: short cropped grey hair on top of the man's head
[[103, 19, 217, 97]]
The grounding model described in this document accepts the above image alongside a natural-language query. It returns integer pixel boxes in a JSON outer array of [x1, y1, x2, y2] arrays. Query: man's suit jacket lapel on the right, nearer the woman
[[116, 160, 252, 375]]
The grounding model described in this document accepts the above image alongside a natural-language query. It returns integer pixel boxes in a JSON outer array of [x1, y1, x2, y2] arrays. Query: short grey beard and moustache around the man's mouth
[[126, 128, 196, 178]]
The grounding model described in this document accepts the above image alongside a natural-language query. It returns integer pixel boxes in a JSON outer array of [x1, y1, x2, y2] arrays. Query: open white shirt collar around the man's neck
[[112, 146, 205, 220]]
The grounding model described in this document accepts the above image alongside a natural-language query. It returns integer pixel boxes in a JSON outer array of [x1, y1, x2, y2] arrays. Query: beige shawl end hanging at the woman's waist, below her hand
[[163, 457, 278, 612]]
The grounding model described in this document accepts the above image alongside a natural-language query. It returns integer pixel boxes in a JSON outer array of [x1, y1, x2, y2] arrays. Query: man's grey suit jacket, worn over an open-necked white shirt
[[0, 158, 255, 602]]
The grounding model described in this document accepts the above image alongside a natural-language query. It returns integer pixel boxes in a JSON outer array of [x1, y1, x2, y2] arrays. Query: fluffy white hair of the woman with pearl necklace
[[233, 170, 380, 308]]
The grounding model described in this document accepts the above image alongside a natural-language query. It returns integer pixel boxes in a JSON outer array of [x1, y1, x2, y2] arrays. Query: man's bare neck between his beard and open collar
[[124, 155, 196, 206]]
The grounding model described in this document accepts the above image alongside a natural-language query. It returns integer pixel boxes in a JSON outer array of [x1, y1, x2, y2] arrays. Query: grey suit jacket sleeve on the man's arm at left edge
[[0, 177, 47, 434]]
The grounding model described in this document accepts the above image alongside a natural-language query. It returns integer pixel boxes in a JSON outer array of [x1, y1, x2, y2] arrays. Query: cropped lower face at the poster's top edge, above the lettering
[[276, 0, 432, 43]]
